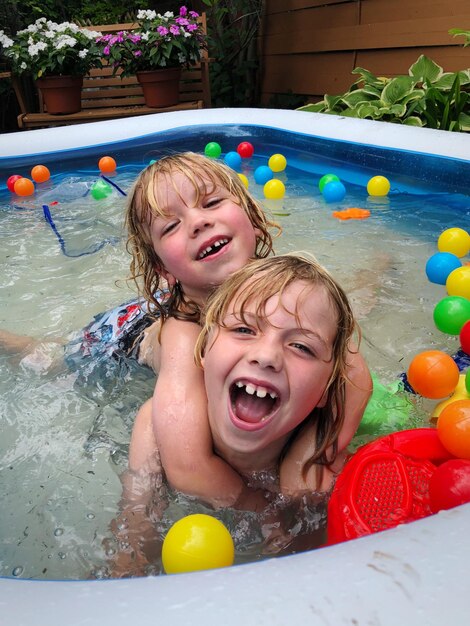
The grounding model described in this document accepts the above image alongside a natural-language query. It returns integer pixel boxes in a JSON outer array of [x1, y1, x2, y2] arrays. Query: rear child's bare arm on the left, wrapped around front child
[[152, 318, 266, 510]]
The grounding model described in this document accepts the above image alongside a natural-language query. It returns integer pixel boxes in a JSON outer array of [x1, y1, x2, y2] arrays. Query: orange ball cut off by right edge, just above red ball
[[437, 400, 470, 459]]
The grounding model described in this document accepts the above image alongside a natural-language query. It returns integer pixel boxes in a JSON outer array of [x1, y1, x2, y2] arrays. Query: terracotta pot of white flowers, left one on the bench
[[0, 17, 101, 113]]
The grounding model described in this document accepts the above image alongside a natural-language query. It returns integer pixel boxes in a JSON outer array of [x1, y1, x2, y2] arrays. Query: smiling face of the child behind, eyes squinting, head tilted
[[150, 172, 256, 303]]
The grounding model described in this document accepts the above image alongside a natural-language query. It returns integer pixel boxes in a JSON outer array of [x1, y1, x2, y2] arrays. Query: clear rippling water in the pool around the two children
[[0, 129, 470, 579]]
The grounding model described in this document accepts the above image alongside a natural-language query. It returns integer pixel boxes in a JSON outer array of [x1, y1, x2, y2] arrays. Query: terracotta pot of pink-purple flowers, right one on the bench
[[97, 6, 206, 107]]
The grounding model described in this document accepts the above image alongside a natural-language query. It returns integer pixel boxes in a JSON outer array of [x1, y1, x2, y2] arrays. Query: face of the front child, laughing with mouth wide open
[[203, 281, 337, 470]]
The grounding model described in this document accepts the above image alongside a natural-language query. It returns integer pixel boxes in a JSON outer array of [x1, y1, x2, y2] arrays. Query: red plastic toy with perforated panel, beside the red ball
[[328, 428, 453, 544]]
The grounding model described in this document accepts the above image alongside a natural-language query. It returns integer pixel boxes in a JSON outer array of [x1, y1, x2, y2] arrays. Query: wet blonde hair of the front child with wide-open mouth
[[195, 253, 359, 477]]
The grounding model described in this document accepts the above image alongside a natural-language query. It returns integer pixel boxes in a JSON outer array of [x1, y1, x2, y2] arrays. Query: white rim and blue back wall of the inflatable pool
[[0, 109, 470, 626]]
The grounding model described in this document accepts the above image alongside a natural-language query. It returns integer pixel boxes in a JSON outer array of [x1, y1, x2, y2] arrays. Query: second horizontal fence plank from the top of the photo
[[263, 15, 470, 55]]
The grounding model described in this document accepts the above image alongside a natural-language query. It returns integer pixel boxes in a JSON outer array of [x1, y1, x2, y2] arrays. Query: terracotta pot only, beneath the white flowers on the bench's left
[[36, 76, 83, 115]]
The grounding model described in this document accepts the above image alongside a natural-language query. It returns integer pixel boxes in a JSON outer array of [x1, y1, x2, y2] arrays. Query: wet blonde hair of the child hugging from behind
[[125, 152, 280, 322]]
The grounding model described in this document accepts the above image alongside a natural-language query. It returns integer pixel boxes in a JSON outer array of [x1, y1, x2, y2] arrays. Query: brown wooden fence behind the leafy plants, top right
[[260, 0, 470, 104]]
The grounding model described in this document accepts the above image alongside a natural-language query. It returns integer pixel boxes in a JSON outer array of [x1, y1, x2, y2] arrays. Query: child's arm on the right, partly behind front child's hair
[[280, 346, 372, 494]]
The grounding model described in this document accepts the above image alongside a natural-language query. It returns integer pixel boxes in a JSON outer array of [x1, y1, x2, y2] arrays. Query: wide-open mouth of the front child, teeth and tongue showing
[[230, 380, 280, 425]]
